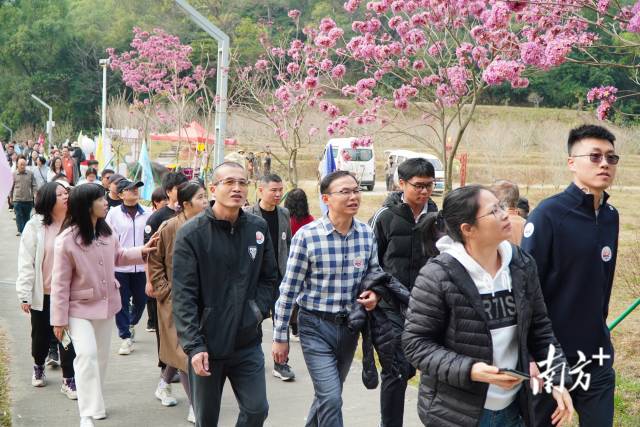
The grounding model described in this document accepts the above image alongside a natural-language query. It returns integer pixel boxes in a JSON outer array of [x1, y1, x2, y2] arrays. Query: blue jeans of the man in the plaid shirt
[[298, 308, 358, 427]]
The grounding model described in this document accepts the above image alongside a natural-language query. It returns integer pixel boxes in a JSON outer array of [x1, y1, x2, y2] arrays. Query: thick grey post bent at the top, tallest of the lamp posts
[[176, 0, 229, 166]]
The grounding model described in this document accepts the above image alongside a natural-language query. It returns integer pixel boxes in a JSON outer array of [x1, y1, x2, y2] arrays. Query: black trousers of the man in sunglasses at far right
[[533, 356, 616, 427]]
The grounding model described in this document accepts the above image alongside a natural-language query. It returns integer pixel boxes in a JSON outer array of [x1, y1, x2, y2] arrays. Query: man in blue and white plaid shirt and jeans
[[272, 171, 381, 427]]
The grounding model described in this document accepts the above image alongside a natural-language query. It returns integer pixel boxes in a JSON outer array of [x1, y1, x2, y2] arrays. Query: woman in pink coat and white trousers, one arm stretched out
[[51, 184, 157, 427]]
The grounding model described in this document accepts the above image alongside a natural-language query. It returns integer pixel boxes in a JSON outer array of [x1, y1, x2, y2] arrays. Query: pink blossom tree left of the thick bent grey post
[[107, 27, 215, 164]]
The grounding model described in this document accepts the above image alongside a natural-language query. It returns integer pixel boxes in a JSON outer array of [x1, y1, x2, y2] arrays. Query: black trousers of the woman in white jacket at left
[[31, 295, 76, 378]]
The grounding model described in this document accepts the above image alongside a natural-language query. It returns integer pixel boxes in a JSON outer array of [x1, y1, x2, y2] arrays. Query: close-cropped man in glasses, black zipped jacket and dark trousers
[[172, 162, 278, 427]]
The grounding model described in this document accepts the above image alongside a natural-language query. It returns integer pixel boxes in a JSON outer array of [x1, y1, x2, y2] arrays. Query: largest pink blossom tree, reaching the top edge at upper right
[[310, 0, 595, 191]]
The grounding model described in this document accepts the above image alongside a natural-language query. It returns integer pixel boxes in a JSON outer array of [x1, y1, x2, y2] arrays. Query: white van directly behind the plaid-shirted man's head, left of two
[[318, 138, 376, 191]]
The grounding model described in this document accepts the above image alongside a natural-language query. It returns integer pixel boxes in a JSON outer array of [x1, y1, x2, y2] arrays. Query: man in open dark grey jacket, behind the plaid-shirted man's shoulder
[[246, 174, 296, 381]]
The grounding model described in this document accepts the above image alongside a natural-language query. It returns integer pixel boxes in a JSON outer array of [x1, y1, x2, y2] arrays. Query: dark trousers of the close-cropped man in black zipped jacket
[[189, 343, 269, 427]]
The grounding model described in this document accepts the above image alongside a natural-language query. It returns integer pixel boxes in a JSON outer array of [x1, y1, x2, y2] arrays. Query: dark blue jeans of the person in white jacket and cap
[[116, 271, 147, 339]]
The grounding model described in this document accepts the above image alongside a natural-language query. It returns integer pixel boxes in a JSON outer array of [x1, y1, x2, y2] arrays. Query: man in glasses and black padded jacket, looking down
[[370, 157, 438, 427]]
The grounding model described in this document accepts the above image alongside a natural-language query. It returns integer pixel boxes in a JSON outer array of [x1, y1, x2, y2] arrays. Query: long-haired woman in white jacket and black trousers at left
[[16, 182, 77, 400]]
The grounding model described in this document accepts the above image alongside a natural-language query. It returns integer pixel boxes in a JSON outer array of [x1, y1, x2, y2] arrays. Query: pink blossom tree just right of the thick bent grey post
[[237, 10, 356, 187]]
